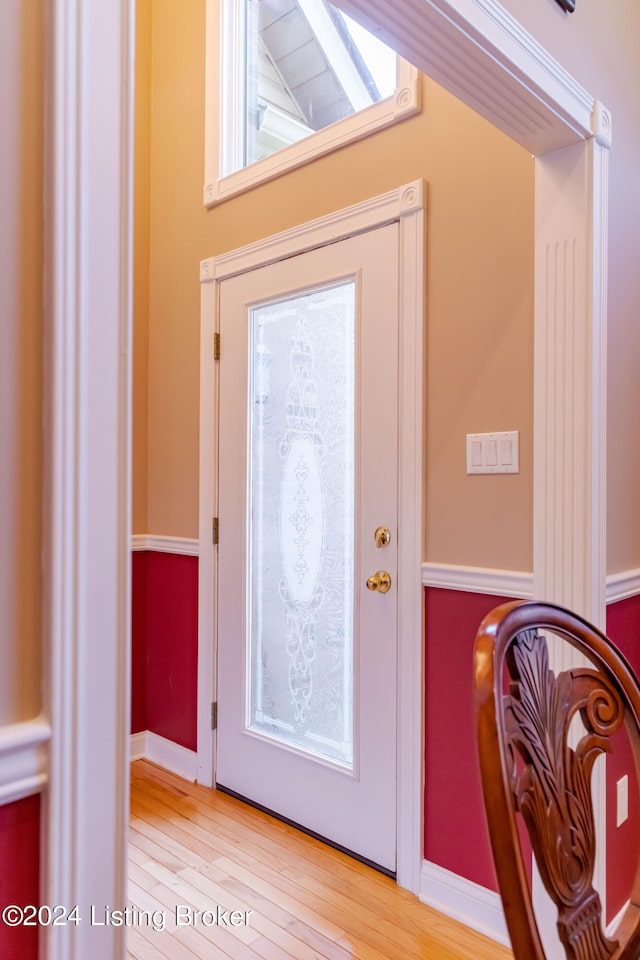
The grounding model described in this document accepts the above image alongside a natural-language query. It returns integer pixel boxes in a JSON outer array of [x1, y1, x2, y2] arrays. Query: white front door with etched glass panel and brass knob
[[216, 223, 399, 871]]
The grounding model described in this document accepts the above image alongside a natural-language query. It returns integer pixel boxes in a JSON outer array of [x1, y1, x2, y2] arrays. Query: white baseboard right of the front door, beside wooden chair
[[419, 860, 511, 947]]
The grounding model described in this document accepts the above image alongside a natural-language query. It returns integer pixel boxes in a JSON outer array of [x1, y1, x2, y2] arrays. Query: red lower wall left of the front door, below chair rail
[[131, 551, 198, 750]]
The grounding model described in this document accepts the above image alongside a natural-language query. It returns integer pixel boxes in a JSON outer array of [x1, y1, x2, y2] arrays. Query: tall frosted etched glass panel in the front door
[[247, 281, 355, 767]]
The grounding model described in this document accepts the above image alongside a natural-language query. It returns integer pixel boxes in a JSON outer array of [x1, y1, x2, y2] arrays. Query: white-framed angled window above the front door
[[204, 0, 420, 206]]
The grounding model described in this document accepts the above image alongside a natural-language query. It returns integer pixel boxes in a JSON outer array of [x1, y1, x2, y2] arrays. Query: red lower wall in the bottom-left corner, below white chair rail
[[0, 796, 40, 960]]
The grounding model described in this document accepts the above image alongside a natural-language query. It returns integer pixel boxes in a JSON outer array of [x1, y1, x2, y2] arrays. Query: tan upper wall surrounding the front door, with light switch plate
[[140, 0, 533, 570]]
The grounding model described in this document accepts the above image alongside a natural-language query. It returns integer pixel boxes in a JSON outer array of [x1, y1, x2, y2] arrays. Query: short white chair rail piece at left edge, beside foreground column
[[0, 717, 51, 806]]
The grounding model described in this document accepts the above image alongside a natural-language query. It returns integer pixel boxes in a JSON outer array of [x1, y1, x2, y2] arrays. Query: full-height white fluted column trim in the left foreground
[[41, 0, 133, 960]]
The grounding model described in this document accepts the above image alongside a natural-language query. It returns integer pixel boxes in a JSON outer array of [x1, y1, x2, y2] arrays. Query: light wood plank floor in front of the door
[[127, 760, 512, 960]]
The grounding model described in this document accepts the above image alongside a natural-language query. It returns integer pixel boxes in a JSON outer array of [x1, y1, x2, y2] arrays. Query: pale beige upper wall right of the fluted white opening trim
[[503, 0, 640, 573]]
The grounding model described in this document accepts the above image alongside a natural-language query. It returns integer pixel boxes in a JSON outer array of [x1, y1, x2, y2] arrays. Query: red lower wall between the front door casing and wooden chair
[[424, 587, 508, 890]]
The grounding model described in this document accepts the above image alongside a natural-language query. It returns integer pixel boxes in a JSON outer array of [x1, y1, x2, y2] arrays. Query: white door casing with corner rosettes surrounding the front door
[[198, 180, 426, 889]]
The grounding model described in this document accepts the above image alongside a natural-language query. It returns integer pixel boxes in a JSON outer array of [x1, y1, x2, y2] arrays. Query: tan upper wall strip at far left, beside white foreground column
[[0, 0, 44, 725]]
